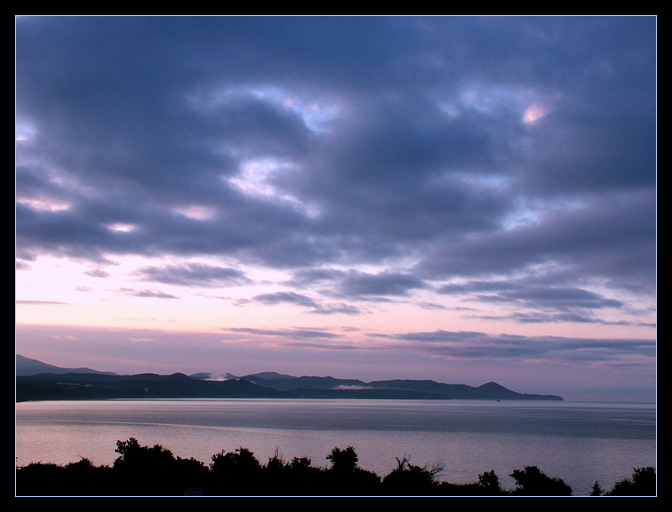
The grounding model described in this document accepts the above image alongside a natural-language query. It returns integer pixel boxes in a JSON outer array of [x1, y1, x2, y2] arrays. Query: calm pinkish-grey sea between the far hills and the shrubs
[[15, 399, 657, 496]]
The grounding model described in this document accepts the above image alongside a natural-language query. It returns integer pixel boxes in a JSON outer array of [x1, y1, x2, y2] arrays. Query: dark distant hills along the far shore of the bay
[[16, 355, 562, 402]]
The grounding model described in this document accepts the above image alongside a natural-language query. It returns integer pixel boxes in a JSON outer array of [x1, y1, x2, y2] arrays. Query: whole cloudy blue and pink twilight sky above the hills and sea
[[15, 16, 657, 401]]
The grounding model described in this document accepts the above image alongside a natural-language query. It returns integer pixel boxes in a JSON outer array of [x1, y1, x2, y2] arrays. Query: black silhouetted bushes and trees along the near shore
[[16, 438, 656, 496]]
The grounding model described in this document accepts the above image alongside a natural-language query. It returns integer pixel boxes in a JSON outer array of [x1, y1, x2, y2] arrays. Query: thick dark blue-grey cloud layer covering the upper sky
[[16, 16, 656, 328]]
